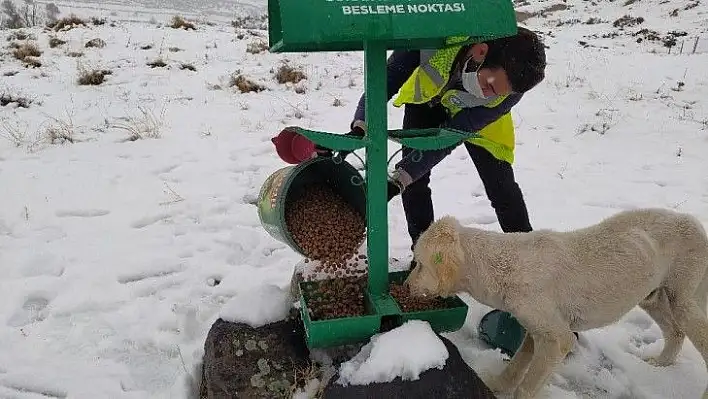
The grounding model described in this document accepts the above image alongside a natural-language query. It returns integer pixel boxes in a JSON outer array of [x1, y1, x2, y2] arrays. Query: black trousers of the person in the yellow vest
[[401, 105, 532, 245]]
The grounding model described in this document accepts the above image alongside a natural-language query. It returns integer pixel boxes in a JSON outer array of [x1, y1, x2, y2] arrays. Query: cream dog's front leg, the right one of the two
[[514, 322, 575, 399]]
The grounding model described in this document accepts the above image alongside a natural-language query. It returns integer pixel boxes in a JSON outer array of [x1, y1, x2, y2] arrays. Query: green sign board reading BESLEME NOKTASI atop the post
[[268, 0, 516, 52]]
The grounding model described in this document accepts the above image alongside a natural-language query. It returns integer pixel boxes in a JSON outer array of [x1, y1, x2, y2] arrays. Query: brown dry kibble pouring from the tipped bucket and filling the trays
[[285, 184, 443, 320]]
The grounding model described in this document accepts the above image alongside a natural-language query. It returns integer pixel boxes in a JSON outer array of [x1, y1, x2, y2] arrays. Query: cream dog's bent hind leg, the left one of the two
[[639, 288, 686, 367]]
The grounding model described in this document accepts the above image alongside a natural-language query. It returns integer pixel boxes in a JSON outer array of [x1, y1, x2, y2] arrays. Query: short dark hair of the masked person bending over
[[482, 26, 546, 93]]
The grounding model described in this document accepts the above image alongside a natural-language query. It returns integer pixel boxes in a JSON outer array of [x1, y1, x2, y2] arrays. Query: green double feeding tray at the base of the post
[[299, 270, 468, 348]]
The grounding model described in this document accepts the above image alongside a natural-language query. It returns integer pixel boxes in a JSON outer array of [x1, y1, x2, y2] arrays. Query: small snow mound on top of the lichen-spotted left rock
[[219, 284, 293, 328]]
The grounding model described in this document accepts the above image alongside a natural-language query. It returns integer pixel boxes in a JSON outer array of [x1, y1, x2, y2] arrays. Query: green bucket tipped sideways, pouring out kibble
[[258, 157, 366, 256]]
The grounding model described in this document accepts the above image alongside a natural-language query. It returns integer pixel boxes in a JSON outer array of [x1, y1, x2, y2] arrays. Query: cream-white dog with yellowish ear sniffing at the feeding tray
[[406, 209, 708, 399]]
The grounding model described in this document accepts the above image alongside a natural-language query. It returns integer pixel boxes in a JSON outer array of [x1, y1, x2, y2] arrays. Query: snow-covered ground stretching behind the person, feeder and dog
[[0, 0, 708, 399]]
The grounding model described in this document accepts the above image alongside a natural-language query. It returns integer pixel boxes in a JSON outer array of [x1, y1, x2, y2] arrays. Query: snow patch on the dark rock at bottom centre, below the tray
[[337, 320, 450, 386]]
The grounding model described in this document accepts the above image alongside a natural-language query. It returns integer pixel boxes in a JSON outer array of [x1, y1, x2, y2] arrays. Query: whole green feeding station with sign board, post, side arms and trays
[[268, 0, 517, 348]]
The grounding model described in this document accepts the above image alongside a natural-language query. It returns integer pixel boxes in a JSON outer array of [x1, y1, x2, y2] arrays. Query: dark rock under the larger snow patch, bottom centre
[[323, 335, 496, 399]]
